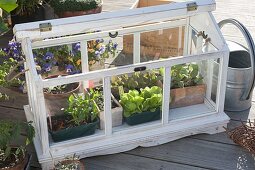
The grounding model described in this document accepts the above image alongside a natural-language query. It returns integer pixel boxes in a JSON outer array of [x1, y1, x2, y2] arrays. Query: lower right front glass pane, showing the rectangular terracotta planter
[[170, 60, 217, 120]]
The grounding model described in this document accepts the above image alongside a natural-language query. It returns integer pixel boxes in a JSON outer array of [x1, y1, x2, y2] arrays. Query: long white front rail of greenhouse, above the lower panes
[[42, 51, 223, 88]]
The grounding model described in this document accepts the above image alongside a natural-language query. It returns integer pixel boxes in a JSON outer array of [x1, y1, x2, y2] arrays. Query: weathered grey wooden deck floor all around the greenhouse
[[0, 0, 255, 170]]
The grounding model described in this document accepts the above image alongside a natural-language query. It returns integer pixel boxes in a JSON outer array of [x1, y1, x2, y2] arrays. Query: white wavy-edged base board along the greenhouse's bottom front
[[23, 104, 229, 169]]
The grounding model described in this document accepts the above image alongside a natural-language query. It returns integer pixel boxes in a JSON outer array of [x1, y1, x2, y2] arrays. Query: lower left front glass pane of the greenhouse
[[44, 76, 104, 143]]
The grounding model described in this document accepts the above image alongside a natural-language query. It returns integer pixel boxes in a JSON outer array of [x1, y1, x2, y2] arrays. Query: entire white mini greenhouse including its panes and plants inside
[[14, 0, 229, 169]]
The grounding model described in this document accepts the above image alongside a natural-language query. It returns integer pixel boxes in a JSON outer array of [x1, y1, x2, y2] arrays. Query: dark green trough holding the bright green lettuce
[[125, 108, 161, 125]]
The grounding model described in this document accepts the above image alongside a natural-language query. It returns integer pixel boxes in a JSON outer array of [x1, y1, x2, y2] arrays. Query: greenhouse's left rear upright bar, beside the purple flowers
[[80, 40, 89, 89]]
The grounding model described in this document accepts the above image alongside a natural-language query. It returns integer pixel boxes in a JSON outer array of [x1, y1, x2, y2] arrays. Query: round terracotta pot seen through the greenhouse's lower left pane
[[44, 75, 81, 115]]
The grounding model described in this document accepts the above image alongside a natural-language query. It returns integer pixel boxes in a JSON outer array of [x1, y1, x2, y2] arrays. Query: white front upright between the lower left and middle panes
[[103, 77, 112, 136]]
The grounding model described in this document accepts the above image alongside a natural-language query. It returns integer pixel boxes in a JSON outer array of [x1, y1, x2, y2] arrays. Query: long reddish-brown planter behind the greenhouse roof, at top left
[[58, 5, 102, 18]]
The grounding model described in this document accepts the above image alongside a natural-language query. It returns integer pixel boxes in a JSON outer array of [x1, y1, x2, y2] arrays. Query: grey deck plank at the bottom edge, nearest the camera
[[83, 153, 208, 170]]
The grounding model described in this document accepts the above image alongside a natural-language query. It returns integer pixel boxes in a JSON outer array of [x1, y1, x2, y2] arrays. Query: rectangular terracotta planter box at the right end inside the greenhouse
[[170, 84, 206, 108]]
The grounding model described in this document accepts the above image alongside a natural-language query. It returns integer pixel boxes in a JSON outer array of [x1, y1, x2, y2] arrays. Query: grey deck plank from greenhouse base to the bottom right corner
[[128, 138, 255, 170]]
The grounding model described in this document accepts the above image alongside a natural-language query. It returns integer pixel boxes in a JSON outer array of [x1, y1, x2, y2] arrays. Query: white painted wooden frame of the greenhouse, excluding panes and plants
[[14, 0, 229, 169]]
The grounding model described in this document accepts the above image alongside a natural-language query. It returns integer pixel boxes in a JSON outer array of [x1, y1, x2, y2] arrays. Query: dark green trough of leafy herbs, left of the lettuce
[[49, 115, 99, 142]]
